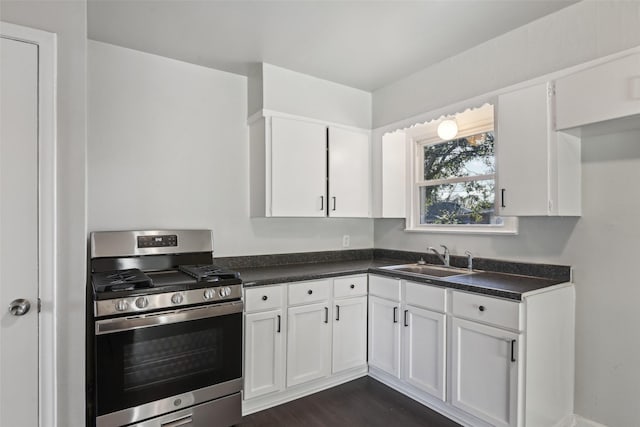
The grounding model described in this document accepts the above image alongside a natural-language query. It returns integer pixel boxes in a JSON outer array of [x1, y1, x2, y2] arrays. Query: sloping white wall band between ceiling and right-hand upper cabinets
[[373, 0, 640, 128]]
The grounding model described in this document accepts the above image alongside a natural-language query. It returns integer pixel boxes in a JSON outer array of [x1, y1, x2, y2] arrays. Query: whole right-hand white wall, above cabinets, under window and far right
[[373, 1, 640, 427]]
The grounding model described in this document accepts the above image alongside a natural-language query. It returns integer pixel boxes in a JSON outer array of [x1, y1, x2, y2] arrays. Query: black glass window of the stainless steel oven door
[[96, 313, 242, 415]]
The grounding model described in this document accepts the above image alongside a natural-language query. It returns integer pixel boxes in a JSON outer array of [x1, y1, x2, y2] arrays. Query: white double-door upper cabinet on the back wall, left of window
[[250, 116, 371, 218]]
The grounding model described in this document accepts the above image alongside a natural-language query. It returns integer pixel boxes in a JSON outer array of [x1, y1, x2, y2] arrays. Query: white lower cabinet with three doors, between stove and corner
[[242, 274, 368, 415]]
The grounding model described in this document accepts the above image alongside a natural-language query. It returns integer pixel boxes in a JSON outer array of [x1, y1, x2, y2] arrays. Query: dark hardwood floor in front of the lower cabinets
[[240, 377, 459, 427]]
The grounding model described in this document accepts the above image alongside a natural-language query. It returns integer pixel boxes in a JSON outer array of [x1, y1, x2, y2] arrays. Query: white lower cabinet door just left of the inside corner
[[332, 296, 367, 374]]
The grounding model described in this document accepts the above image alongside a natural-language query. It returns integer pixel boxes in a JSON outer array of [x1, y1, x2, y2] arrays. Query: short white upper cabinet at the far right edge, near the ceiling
[[556, 53, 640, 130]]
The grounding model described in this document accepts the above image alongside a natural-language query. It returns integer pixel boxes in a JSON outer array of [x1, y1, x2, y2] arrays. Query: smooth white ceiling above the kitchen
[[88, 0, 576, 91]]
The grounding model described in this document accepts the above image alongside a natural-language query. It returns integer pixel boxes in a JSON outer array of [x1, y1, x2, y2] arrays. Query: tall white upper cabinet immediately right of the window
[[496, 83, 581, 216]]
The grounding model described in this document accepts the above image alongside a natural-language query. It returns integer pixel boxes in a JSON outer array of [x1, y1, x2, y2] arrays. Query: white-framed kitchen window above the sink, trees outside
[[407, 105, 517, 233]]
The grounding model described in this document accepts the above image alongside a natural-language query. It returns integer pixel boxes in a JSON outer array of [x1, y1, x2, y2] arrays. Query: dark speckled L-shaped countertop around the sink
[[237, 259, 568, 301]]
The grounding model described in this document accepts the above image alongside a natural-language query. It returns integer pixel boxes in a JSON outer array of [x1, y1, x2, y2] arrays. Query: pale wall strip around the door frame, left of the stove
[[0, 0, 87, 426]]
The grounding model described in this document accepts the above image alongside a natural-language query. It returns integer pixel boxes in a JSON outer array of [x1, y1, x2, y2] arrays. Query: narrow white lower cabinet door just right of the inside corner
[[369, 297, 400, 377]]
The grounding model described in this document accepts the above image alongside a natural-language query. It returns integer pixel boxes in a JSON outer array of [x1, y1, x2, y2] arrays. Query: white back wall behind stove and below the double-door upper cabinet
[[88, 41, 373, 256]]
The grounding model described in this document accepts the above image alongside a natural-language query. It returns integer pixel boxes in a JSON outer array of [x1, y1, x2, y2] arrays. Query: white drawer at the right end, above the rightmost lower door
[[452, 291, 522, 330]]
